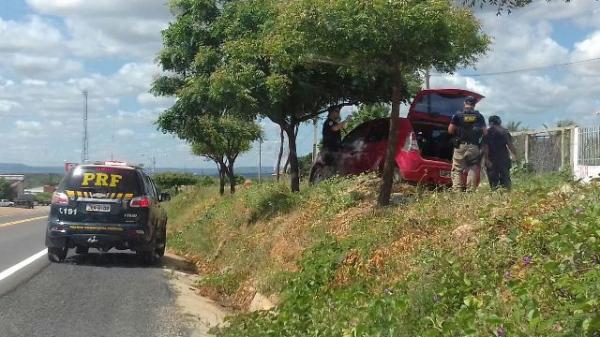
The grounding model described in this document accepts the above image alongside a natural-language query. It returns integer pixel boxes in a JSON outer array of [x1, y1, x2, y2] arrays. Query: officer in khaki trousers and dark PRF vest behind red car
[[448, 96, 486, 191]]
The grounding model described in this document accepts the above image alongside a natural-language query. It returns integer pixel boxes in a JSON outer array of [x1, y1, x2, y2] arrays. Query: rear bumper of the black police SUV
[[46, 222, 151, 250]]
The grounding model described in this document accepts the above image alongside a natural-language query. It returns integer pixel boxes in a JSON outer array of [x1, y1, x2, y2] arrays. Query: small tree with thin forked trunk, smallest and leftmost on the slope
[[190, 116, 262, 194]]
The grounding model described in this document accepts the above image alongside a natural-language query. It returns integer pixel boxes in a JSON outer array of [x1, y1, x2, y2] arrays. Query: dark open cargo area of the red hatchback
[[412, 121, 454, 162]]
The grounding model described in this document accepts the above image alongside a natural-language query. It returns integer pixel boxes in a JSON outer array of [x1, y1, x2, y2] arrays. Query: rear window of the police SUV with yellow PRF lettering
[[61, 166, 141, 194]]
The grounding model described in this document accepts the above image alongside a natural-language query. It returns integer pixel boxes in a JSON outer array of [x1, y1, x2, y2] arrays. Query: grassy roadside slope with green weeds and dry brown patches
[[169, 176, 600, 336]]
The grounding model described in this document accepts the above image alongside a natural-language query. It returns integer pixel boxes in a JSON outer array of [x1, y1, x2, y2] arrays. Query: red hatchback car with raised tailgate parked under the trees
[[310, 89, 483, 186]]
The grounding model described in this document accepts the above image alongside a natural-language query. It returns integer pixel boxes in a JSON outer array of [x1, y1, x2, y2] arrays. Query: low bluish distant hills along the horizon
[[0, 163, 273, 177]]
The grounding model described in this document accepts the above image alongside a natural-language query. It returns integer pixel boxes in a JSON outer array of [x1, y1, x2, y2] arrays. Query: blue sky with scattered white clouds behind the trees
[[0, 0, 600, 168]]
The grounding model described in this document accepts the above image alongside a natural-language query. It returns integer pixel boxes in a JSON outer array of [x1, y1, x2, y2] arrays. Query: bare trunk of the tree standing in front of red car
[[377, 74, 402, 206]]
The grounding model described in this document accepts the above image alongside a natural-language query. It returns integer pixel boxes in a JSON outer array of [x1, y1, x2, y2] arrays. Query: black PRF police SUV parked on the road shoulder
[[46, 162, 169, 263]]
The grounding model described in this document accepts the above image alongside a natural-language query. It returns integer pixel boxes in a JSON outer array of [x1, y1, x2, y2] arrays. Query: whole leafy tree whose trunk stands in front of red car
[[272, 0, 490, 205]]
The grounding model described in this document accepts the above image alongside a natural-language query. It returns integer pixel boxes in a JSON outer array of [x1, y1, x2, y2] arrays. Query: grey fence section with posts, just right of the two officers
[[512, 127, 575, 173]]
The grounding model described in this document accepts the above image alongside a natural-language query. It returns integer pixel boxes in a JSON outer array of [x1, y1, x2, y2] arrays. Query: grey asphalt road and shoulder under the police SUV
[[0, 209, 189, 337]]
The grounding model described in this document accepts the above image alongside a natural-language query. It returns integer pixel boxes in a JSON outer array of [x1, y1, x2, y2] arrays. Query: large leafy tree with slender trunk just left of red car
[[153, 0, 390, 191]]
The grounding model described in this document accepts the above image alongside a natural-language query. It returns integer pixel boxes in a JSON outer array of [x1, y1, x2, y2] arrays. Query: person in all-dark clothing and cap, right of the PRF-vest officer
[[483, 116, 518, 190]]
